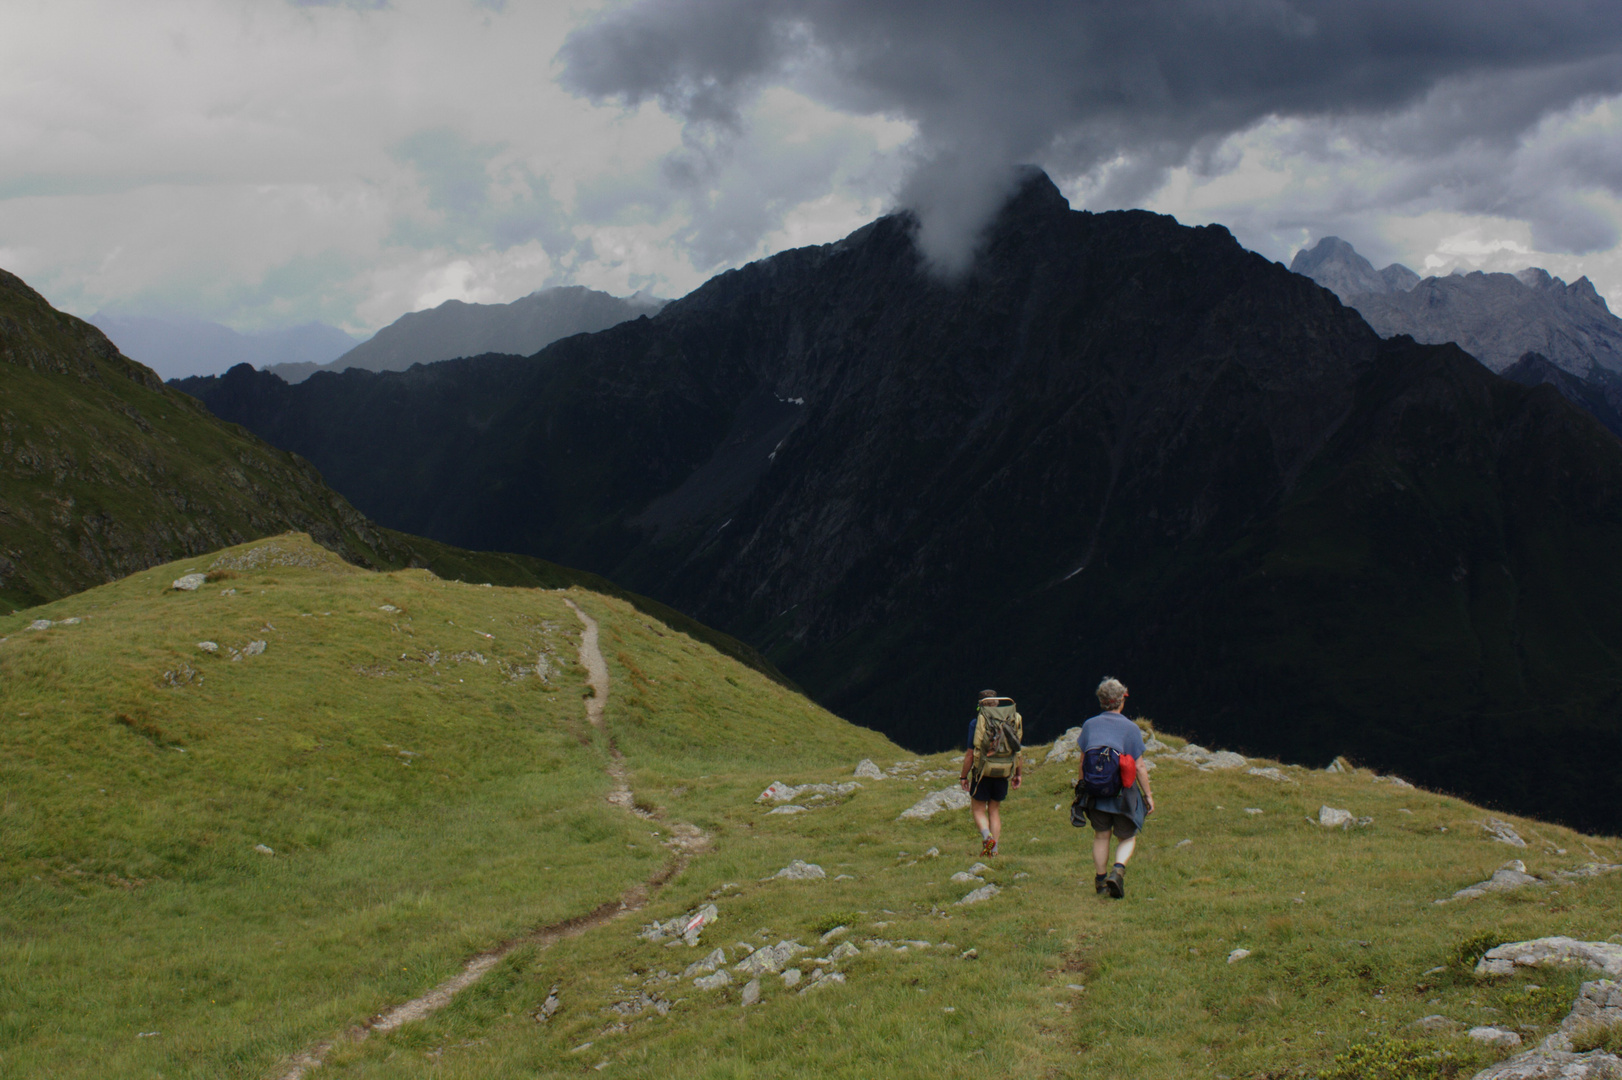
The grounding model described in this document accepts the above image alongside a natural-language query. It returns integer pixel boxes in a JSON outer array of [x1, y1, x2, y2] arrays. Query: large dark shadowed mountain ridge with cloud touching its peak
[[174, 175, 1622, 827]]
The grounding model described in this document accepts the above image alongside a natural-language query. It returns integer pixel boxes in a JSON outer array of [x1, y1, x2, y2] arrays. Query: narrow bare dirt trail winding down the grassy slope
[[277, 600, 710, 1080]]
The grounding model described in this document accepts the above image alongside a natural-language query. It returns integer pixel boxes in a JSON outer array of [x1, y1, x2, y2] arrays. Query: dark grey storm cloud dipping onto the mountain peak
[[560, 0, 1622, 268]]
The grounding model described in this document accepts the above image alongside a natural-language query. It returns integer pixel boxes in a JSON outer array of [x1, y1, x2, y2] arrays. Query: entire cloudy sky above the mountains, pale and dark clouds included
[[0, 0, 1622, 332]]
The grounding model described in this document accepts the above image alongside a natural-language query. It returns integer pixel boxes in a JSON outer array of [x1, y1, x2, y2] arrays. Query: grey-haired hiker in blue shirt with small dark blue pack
[[1072, 676, 1155, 900]]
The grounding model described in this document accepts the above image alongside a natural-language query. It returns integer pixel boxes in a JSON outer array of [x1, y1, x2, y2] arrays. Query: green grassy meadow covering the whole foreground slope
[[0, 535, 1622, 1080]]
